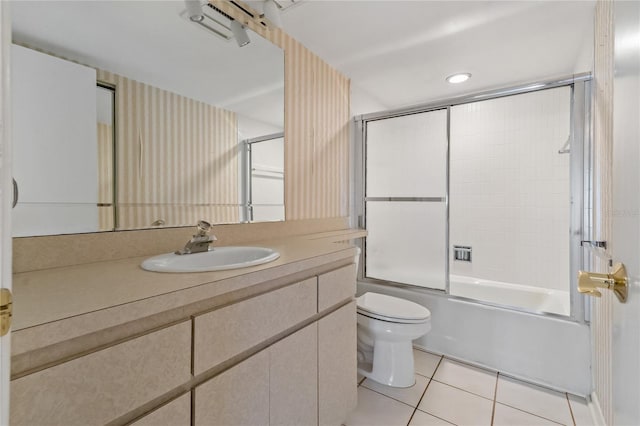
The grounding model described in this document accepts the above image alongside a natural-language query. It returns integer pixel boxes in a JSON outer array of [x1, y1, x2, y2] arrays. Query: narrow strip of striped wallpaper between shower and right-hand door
[[589, 0, 615, 425]]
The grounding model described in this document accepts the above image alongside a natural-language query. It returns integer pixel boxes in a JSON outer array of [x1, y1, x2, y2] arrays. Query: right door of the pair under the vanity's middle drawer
[[269, 323, 318, 426]]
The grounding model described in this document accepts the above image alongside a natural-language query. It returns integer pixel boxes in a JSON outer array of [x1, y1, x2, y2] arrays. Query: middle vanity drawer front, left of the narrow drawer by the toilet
[[193, 277, 317, 375]]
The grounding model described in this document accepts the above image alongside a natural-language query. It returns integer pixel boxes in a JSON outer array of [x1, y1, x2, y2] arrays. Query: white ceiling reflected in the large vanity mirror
[[11, 0, 284, 137]]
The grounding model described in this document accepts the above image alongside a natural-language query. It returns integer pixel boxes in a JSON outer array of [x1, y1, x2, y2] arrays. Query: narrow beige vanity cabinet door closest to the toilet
[[318, 301, 358, 425]]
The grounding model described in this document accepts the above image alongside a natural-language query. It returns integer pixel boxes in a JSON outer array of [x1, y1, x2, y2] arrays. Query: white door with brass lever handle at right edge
[[611, 1, 640, 425]]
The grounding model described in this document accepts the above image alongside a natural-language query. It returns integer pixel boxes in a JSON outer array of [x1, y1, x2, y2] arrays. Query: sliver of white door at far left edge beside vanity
[[0, 1, 13, 425]]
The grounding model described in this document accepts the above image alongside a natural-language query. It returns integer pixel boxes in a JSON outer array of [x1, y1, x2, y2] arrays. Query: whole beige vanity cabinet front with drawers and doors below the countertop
[[11, 263, 357, 426]]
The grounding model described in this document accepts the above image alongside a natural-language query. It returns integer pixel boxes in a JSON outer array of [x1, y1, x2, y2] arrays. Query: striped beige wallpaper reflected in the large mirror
[[98, 70, 239, 229]]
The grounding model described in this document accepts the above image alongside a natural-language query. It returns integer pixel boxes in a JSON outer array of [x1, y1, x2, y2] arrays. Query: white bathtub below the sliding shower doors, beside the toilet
[[357, 279, 591, 396]]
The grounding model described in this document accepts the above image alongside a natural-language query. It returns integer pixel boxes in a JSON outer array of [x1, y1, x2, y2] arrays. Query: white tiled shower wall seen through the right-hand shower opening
[[449, 87, 571, 291]]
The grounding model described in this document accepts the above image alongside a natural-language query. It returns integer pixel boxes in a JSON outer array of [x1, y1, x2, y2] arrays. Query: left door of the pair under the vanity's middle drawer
[[194, 350, 269, 426]]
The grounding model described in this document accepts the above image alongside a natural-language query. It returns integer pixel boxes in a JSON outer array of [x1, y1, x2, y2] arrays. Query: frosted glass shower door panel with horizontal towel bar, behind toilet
[[365, 109, 448, 290]]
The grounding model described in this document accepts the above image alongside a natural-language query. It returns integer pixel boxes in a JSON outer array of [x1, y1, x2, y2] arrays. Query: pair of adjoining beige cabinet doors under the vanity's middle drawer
[[193, 323, 318, 426]]
